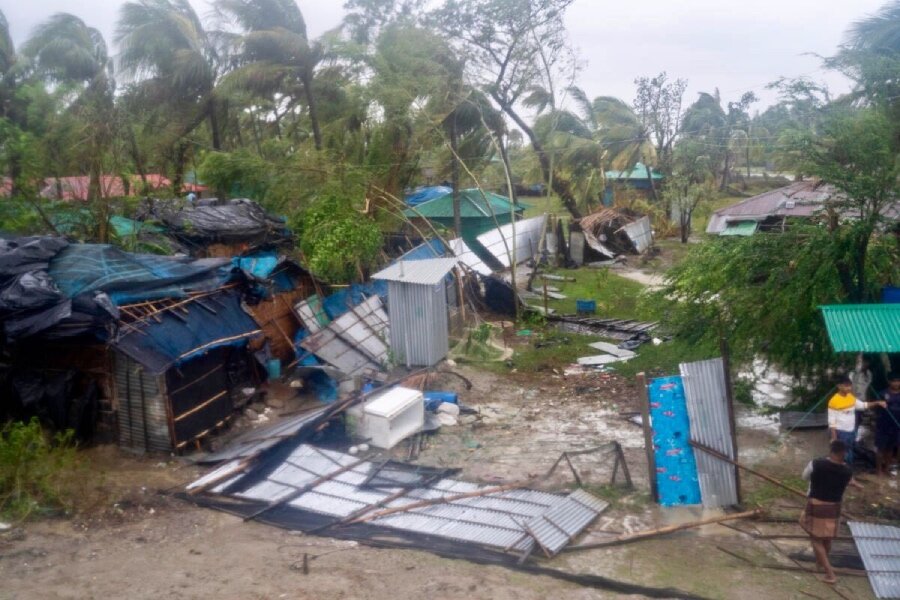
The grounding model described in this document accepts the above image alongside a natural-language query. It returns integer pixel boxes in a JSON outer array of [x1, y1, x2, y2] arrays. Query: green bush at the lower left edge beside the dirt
[[0, 419, 78, 519]]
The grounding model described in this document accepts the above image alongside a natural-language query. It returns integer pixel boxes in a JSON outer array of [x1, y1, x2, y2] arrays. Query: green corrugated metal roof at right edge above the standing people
[[820, 304, 900, 352]]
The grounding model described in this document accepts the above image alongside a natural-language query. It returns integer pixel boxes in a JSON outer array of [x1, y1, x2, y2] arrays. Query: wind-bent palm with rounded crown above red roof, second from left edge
[[23, 13, 115, 204]]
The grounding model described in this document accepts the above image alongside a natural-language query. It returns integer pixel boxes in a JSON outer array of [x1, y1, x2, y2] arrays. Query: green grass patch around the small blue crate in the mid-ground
[[531, 267, 646, 319]]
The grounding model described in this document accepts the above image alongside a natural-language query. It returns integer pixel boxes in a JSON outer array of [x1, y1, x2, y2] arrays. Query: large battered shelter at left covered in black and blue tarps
[[0, 237, 316, 451]]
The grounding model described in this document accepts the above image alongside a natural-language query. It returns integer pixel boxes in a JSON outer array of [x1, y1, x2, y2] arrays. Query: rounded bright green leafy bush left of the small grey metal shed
[[294, 194, 381, 283]]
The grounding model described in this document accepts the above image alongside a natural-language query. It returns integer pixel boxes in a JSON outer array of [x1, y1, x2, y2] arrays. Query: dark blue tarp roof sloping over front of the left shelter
[[111, 290, 262, 374]]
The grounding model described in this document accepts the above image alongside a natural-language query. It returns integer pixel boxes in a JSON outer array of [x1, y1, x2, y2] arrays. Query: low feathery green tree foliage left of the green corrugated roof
[[652, 224, 896, 375]]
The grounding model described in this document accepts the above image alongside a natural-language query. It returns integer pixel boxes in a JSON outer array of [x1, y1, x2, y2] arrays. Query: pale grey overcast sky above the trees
[[0, 0, 886, 108]]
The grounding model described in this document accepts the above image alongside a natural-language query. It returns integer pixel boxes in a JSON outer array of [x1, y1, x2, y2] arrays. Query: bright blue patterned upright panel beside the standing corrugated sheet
[[649, 377, 701, 506]]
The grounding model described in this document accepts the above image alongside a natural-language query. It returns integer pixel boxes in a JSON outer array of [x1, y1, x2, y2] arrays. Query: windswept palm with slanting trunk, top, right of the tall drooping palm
[[215, 0, 324, 150]]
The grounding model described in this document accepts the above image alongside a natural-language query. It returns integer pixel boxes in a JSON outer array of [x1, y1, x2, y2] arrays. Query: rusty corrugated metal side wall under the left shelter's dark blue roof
[[113, 352, 172, 452]]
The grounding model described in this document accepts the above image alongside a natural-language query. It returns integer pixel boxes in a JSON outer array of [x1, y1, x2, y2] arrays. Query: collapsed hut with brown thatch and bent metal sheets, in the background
[[569, 208, 653, 266]]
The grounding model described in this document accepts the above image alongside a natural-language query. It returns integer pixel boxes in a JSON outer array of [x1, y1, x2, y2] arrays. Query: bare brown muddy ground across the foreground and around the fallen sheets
[[0, 368, 888, 600]]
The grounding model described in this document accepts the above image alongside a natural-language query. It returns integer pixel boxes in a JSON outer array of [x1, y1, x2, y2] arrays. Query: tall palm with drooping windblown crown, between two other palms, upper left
[[116, 0, 223, 194]]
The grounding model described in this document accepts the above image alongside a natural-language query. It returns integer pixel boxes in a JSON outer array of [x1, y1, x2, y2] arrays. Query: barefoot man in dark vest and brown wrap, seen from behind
[[800, 440, 862, 583]]
